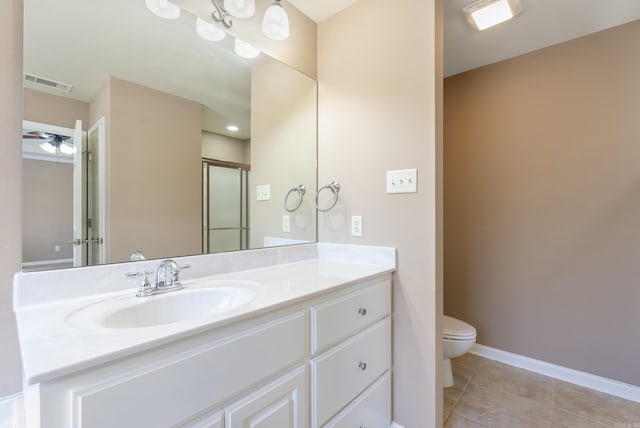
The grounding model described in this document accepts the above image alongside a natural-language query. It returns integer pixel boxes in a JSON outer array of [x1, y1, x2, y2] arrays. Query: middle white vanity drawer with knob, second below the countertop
[[311, 317, 391, 428]]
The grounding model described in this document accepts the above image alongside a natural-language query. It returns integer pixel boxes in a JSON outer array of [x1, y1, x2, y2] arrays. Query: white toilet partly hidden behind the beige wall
[[442, 315, 476, 388]]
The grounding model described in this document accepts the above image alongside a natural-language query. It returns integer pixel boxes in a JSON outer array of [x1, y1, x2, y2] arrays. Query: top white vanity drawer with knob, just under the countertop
[[311, 279, 391, 354]]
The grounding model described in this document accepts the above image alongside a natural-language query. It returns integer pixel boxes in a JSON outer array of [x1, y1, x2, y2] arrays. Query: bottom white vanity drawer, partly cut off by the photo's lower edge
[[323, 372, 391, 428]]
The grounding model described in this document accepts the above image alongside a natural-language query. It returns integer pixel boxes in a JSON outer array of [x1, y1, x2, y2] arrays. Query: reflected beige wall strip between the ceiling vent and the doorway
[[24, 88, 91, 129]]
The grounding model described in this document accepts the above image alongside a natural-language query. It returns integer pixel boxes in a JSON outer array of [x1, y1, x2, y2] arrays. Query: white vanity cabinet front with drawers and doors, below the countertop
[[25, 273, 391, 428]]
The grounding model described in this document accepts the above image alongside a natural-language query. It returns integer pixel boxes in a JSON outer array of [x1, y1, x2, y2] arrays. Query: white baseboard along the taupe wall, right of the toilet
[[470, 344, 640, 403]]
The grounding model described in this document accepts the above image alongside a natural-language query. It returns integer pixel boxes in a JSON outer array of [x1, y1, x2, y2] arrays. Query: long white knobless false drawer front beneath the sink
[[71, 311, 306, 428]]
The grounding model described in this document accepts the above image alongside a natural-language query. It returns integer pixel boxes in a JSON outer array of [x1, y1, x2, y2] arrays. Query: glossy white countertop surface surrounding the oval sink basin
[[15, 246, 395, 385]]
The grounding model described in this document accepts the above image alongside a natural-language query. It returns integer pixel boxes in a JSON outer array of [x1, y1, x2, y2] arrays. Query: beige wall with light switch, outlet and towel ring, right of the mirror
[[318, 0, 442, 428]]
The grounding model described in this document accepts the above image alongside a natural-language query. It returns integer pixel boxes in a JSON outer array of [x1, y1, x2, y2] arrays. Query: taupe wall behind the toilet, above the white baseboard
[[444, 21, 640, 385]]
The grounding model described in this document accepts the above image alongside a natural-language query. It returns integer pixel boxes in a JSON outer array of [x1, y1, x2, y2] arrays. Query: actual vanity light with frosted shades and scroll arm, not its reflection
[[211, 0, 289, 40]]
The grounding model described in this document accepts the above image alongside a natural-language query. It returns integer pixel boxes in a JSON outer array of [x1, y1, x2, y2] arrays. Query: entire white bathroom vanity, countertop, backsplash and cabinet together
[[15, 244, 395, 428]]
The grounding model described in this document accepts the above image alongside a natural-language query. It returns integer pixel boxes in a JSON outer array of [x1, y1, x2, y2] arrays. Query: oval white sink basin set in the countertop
[[66, 281, 262, 329]]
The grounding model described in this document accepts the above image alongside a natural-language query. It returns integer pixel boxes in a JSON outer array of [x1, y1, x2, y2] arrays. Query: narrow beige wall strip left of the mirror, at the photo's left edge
[[0, 0, 22, 397]]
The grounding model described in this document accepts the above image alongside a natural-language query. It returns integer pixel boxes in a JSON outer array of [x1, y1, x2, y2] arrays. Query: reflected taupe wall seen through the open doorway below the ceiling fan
[[22, 159, 73, 262]]
